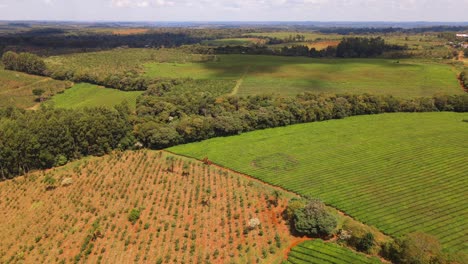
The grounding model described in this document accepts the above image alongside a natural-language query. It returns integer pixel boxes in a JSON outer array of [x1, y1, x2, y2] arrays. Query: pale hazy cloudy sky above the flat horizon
[[0, 0, 468, 22]]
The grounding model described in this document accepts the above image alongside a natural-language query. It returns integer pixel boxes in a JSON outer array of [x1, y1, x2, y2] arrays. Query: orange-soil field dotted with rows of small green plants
[[0, 151, 293, 263]]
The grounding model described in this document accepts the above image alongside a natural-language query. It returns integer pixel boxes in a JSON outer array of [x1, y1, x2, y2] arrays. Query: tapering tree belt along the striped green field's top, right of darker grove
[[135, 92, 468, 149]]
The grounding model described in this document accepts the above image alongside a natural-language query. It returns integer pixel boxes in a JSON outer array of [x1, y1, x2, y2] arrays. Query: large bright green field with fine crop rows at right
[[170, 113, 468, 252]]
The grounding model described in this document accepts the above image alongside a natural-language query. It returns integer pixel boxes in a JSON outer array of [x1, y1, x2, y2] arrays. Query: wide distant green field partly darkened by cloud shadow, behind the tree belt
[[145, 55, 463, 97]]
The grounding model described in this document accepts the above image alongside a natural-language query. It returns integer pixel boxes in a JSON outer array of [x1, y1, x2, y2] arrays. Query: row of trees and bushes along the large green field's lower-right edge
[[284, 199, 468, 264]]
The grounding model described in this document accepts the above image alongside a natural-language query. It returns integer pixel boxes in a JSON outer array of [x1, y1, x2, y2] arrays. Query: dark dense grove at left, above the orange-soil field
[[0, 104, 134, 180]]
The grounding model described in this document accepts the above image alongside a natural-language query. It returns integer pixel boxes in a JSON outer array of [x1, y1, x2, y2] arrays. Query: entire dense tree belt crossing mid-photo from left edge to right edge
[[0, 92, 468, 179]]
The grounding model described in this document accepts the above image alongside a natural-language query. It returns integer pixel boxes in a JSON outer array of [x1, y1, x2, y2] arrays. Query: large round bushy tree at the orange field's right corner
[[294, 200, 338, 236]]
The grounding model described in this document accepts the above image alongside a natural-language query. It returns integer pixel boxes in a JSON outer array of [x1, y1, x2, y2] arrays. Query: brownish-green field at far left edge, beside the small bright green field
[[0, 68, 71, 108]]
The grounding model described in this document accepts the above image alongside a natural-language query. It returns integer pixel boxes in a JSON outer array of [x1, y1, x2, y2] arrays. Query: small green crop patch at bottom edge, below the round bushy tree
[[288, 239, 382, 264]]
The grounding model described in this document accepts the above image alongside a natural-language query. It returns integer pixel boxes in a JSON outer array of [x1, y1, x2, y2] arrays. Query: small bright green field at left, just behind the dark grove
[[50, 83, 143, 110]]
